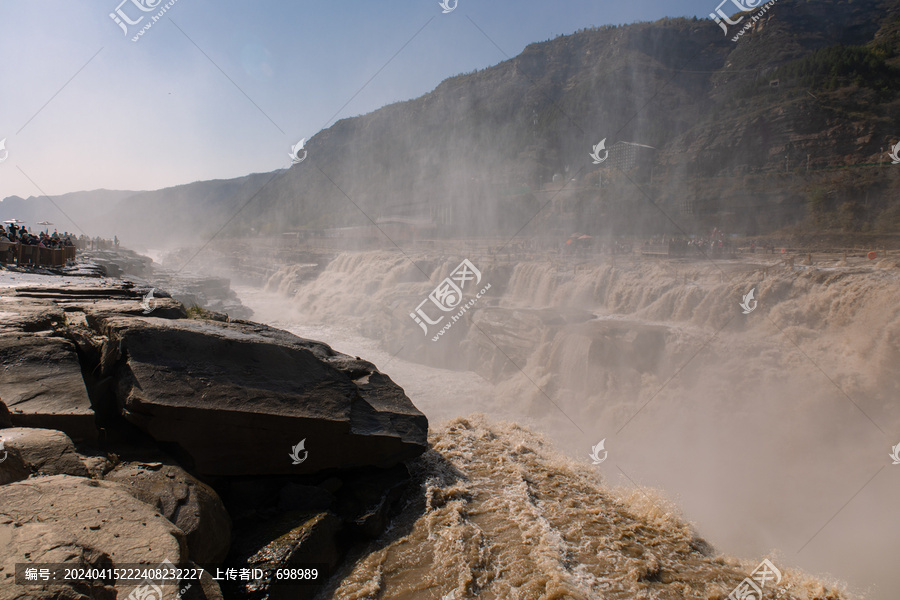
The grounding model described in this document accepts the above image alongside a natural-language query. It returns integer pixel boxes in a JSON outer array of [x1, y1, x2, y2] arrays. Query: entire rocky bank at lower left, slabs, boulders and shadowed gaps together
[[0, 275, 428, 600]]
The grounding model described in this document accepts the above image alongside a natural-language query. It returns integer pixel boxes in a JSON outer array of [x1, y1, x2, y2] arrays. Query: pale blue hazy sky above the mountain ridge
[[0, 0, 717, 198]]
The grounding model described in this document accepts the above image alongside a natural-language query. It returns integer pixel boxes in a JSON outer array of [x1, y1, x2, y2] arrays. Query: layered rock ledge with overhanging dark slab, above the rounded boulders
[[0, 283, 428, 476]]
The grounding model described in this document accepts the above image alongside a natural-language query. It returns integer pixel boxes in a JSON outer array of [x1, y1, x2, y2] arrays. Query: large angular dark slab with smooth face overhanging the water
[[87, 310, 428, 475]]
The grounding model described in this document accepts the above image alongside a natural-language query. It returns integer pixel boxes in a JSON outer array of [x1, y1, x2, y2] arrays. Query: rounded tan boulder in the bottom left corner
[[0, 475, 188, 598]]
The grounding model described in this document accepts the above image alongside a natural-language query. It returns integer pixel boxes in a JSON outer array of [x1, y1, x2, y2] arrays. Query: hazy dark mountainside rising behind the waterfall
[[3, 0, 900, 243]]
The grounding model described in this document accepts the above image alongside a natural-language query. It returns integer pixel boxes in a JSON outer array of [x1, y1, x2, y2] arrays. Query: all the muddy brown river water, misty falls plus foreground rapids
[[238, 252, 900, 600]]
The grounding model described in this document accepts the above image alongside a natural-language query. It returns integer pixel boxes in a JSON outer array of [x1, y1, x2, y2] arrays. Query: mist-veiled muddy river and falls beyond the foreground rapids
[[236, 252, 900, 600]]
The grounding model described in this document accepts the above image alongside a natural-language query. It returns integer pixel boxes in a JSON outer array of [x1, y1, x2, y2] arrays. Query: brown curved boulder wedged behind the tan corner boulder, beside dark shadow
[[105, 463, 231, 564]]
